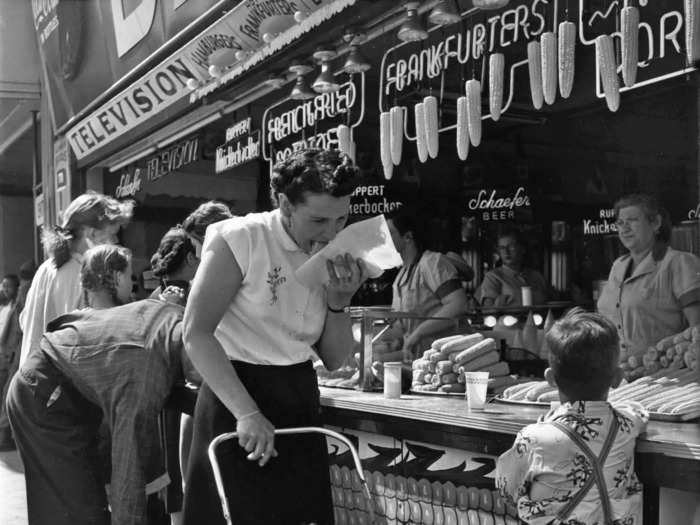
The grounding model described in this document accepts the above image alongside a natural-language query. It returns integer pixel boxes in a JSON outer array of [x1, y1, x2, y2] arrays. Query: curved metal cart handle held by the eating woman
[[207, 427, 375, 525]]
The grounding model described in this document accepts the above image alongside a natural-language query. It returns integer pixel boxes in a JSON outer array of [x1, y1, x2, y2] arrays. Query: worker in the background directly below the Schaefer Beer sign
[[476, 228, 547, 308]]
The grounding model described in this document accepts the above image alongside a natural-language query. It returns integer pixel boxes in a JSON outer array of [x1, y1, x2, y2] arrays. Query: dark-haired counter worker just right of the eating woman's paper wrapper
[[385, 206, 474, 360]]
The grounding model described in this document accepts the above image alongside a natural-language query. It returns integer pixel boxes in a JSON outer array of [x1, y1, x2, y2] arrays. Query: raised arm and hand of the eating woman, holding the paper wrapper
[[317, 254, 367, 370]]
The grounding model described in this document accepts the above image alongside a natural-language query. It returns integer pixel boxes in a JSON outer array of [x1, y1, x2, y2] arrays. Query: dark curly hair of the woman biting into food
[[270, 149, 359, 206]]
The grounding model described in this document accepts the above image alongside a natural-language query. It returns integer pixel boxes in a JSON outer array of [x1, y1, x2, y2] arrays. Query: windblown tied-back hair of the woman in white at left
[[42, 191, 134, 268]]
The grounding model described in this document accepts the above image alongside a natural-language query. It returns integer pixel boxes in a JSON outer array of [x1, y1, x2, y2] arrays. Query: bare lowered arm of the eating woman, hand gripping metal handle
[[184, 236, 276, 464]]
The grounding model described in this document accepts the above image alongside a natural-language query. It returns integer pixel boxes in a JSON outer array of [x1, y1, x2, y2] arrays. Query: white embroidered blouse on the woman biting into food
[[203, 210, 327, 366]]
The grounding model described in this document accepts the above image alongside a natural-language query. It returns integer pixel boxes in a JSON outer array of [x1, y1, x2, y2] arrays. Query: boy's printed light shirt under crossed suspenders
[[496, 401, 649, 525]]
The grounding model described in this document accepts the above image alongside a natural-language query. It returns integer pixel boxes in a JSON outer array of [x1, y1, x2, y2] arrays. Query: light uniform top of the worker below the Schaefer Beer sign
[[476, 266, 547, 306]]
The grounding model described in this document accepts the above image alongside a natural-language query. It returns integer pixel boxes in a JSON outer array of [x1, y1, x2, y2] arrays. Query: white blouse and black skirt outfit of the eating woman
[[183, 210, 333, 525]]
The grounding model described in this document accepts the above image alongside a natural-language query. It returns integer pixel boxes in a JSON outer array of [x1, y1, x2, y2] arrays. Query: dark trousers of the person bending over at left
[[7, 368, 109, 525]]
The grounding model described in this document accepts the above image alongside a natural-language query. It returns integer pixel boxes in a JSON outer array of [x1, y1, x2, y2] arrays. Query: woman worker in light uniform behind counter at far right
[[598, 194, 700, 364]]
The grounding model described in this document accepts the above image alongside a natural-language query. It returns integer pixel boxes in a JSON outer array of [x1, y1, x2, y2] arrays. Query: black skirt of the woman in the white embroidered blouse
[[183, 361, 334, 525]]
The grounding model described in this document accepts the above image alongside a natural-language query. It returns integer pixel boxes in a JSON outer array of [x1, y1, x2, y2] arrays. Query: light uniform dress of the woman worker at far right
[[598, 246, 700, 359]]
